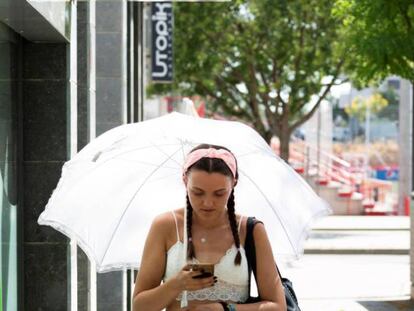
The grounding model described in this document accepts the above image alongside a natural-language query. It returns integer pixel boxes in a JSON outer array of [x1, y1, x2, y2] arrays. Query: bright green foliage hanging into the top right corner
[[333, 0, 414, 86]]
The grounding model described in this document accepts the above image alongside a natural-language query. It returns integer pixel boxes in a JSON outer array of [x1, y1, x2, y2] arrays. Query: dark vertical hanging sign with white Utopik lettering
[[151, 2, 173, 82]]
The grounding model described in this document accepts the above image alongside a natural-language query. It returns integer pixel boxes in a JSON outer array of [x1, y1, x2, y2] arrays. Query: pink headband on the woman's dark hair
[[183, 148, 236, 178]]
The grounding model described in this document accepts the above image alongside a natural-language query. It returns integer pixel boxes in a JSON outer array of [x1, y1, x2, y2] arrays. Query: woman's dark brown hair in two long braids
[[186, 144, 242, 265]]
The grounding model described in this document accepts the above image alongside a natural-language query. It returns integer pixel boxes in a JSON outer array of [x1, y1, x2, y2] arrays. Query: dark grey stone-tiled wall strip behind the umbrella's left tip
[[20, 41, 68, 310]]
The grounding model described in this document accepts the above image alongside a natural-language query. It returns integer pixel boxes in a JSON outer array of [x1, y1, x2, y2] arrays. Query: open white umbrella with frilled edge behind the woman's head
[[38, 113, 330, 272]]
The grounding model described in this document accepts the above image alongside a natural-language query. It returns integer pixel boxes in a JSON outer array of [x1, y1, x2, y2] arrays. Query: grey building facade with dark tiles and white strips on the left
[[0, 0, 144, 311]]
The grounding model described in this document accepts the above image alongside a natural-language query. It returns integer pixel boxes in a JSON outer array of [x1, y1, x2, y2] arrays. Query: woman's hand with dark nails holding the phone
[[174, 265, 220, 294]]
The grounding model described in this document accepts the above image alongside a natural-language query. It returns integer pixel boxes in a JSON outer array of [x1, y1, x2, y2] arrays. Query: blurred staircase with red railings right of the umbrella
[[272, 140, 397, 216]]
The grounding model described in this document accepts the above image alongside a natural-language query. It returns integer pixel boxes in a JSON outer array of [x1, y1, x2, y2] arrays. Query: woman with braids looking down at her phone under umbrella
[[134, 144, 286, 311]]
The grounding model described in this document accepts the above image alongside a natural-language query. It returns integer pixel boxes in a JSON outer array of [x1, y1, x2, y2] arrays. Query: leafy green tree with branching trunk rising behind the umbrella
[[150, 0, 344, 160]]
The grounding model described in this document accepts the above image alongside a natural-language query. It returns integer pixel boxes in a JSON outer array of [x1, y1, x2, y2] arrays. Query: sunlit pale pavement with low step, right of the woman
[[281, 216, 414, 311]]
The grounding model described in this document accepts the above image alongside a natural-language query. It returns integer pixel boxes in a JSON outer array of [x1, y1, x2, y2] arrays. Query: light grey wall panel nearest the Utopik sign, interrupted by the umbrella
[[96, 0, 127, 311]]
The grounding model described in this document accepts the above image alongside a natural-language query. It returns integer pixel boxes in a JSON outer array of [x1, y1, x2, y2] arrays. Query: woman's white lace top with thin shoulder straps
[[164, 212, 249, 302]]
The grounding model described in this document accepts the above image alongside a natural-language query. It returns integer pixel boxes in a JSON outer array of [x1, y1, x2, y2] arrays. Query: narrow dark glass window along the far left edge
[[0, 23, 18, 311]]
